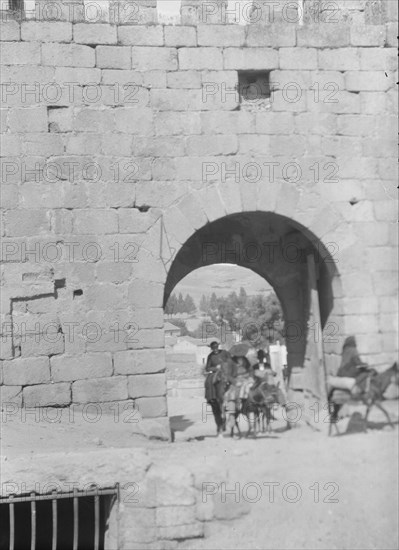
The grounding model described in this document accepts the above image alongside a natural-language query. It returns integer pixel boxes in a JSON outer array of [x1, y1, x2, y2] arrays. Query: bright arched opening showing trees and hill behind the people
[[165, 264, 286, 441]]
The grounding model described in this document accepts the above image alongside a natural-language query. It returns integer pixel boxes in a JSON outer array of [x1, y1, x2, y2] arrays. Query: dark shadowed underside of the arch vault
[[164, 211, 339, 376]]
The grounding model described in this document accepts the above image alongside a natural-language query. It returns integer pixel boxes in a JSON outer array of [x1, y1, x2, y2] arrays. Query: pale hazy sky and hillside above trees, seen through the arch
[[173, 264, 272, 305]]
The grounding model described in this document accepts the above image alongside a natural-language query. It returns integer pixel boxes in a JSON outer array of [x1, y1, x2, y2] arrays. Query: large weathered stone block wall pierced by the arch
[[1, 0, 397, 432]]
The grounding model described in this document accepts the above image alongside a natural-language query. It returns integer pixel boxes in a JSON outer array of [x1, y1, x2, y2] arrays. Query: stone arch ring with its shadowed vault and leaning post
[[139, 194, 345, 426]]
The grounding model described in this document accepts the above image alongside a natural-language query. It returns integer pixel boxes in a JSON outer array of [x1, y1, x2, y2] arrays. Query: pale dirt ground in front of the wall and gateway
[[1, 398, 399, 550]]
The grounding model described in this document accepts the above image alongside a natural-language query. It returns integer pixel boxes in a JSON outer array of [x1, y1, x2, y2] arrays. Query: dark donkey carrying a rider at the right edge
[[328, 362, 399, 435]]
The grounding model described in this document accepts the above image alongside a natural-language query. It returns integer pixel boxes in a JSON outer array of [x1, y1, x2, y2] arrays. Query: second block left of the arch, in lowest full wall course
[[72, 376, 128, 403]]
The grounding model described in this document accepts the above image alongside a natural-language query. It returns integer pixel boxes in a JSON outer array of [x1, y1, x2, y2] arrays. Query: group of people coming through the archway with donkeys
[[205, 341, 285, 435]]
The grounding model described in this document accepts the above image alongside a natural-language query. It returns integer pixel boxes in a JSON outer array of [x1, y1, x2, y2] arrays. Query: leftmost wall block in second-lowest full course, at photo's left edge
[[3, 357, 50, 386]]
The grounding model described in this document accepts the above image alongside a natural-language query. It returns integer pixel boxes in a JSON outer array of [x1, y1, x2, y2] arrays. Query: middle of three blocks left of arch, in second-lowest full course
[[50, 353, 113, 382]]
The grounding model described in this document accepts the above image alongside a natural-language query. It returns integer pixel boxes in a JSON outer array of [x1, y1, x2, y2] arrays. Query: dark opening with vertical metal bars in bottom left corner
[[0, 484, 119, 550]]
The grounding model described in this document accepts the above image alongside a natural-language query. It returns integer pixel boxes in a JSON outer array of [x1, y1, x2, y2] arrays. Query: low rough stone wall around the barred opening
[[0, 449, 250, 550]]
